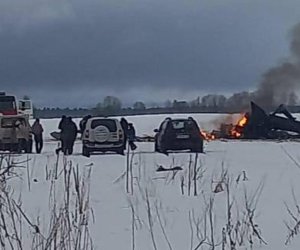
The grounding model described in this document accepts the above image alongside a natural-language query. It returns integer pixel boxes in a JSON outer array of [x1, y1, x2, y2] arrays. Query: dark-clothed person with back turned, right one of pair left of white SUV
[[62, 117, 77, 155]]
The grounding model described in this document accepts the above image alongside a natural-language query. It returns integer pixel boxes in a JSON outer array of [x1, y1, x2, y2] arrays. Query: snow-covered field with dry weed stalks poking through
[[3, 114, 300, 250]]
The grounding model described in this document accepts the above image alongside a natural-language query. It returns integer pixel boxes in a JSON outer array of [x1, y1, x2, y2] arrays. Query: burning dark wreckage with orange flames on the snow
[[207, 102, 300, 139]]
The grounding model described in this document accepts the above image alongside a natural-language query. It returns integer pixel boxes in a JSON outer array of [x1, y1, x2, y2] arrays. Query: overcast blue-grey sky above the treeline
[[0, 0, 300, 107]]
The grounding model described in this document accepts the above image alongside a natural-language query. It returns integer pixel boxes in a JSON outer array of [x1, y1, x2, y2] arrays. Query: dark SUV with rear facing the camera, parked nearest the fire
[[154, 117, 203, 154]]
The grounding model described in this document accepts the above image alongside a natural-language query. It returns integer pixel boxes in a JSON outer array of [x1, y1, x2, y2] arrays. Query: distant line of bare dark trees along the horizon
[[34, 92, 300, 118]]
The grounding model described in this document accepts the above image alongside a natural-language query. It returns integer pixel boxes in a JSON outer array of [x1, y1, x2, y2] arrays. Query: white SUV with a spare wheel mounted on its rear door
[[82, 117, 125, 157]]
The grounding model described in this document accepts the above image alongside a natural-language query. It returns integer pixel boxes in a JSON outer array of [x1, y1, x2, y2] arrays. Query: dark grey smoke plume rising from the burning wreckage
[[227, 23, 300, 109]]
